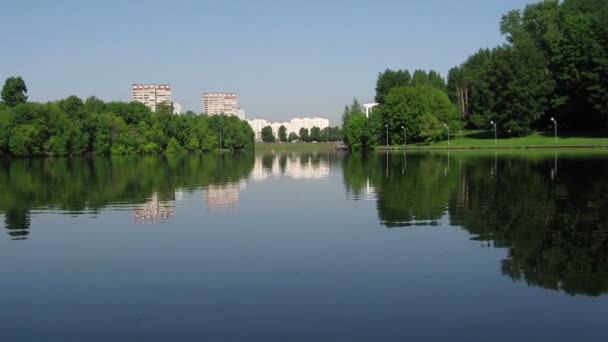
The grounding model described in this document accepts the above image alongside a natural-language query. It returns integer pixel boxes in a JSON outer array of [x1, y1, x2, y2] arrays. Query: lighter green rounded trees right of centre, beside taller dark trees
[[342, 69, 461, 150]]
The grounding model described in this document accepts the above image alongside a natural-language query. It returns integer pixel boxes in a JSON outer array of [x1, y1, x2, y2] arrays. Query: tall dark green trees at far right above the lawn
[[448, 0, 608, 135]]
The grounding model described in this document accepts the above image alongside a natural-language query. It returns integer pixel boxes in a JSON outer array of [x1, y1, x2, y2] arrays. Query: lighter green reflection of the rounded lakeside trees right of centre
[[344, 153, 458, 227]]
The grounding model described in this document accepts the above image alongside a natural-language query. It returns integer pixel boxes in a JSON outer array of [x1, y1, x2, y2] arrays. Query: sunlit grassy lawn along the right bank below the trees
[[377, 131, 608, 150]]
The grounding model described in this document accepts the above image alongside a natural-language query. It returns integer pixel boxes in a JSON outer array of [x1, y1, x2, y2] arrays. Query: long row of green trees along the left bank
[[0, 77, 254, 157]]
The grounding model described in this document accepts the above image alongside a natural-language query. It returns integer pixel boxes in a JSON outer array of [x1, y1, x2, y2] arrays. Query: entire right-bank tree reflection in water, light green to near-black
[[343, 154, 608, 295]]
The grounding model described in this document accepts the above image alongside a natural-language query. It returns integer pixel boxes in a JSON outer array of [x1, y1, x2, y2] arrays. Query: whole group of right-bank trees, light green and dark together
[[343, 0, 608, 149]]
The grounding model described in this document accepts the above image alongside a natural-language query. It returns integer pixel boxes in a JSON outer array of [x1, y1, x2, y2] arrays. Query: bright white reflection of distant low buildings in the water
[[249, 155, 329, 181]]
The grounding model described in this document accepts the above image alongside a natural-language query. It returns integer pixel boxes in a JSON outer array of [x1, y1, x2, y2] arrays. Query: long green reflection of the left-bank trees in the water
[[0, 153, 254, 237]]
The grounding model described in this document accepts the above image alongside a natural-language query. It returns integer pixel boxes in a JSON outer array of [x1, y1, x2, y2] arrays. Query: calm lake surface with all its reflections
[[0, 151, 608, 342]]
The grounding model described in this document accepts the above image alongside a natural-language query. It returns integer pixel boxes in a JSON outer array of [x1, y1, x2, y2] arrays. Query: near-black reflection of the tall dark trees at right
[[450, 159, 608, 295]]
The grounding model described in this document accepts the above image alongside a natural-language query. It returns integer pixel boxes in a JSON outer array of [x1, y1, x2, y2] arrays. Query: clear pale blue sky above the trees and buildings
[[0, 0, 531, 124]]
